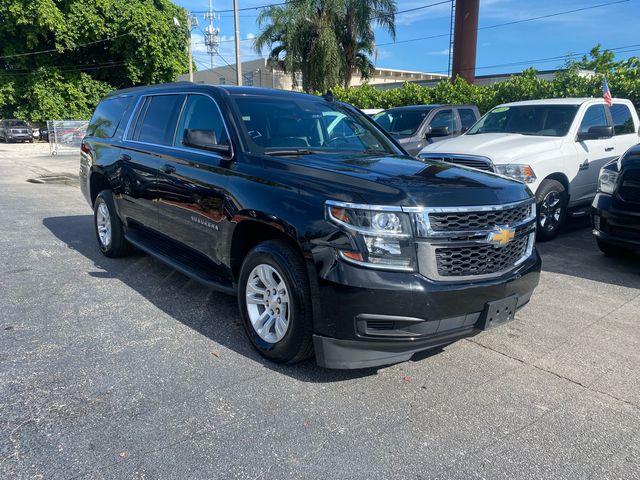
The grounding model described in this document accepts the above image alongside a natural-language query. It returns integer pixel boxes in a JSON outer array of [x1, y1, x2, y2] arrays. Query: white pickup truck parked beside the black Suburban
[[418, 98, 640, 240]]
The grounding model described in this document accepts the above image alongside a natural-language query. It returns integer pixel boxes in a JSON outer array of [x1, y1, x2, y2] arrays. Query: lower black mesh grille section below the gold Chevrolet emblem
[[435, 236, 529, 277]]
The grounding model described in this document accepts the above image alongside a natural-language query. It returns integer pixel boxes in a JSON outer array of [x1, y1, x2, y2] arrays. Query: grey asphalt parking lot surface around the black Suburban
[[0, 144, 640, 479]]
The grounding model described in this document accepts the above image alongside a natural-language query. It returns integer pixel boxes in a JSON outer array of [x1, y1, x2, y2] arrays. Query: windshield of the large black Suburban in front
[[234, 95, 400, 155]]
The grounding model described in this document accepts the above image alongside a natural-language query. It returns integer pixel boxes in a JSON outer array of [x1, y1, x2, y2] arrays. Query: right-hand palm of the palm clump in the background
[[337, 0, 397, 87]]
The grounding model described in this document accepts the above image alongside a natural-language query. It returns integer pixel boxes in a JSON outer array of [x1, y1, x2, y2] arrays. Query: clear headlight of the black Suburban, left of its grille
[[327, 201, 415, 271]]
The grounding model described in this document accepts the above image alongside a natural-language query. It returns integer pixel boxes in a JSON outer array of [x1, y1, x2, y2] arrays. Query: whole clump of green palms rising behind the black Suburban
[[254, 0, 396, 92]]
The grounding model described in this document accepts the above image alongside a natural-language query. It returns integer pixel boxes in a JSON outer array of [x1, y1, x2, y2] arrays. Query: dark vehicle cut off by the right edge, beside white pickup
[[591, 145, 640, 256]]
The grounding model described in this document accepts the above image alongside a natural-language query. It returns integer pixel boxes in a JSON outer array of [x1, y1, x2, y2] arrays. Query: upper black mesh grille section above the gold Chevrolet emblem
[[429, 205, 531, 232]]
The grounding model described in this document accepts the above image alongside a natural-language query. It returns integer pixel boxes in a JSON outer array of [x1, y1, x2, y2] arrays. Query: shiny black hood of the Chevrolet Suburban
[[264, 155, 531, 207]]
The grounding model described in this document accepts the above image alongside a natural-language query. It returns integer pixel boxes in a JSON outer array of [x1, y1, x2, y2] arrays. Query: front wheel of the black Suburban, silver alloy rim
[[238, 240, 313, 364]]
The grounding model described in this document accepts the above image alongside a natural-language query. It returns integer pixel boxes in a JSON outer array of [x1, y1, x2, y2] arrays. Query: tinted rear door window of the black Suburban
[[134, 95, 184, 145]]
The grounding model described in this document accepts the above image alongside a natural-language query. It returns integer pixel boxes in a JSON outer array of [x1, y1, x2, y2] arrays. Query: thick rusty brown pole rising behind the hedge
[[451, 0, 480, 83]]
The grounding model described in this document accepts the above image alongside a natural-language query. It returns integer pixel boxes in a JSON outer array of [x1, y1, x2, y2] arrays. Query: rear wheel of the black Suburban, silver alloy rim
[[93, 190, 131, 258]]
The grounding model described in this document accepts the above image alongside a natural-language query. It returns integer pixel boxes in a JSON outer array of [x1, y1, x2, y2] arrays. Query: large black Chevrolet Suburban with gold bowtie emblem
[[80, 83, 541, 368]]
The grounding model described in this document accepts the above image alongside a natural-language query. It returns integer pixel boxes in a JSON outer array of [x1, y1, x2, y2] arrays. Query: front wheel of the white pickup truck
[[536, 179, 569, 242]]
